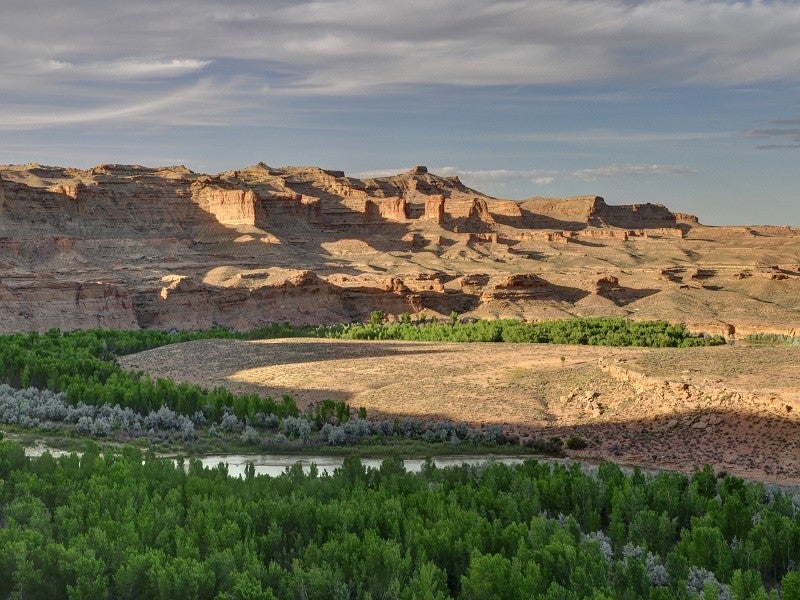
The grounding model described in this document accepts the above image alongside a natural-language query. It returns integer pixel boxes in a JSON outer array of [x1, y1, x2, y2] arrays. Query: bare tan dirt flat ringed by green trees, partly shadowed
[[120, 339, 800, 485]]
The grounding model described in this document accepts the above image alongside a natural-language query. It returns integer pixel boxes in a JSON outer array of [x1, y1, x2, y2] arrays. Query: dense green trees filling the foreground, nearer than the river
[[0, 441, 800, 600]]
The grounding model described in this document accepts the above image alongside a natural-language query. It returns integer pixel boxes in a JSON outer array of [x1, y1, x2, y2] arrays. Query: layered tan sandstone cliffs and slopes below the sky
[[0, 163, 800, 333]]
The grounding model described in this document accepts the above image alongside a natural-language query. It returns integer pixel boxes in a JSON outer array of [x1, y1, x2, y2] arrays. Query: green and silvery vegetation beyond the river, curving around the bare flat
[[0, 318, 721, 455]]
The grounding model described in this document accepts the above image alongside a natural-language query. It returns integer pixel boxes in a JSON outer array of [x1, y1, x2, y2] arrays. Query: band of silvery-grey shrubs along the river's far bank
[[0, 383, 556, 456]]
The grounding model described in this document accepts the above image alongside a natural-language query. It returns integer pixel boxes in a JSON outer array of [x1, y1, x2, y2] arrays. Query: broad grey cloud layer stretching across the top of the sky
[[0, 0, 800, 127]]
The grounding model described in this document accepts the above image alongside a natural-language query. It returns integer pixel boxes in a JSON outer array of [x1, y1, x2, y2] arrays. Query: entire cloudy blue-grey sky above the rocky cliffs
[[0, 0, 800, 226]]
